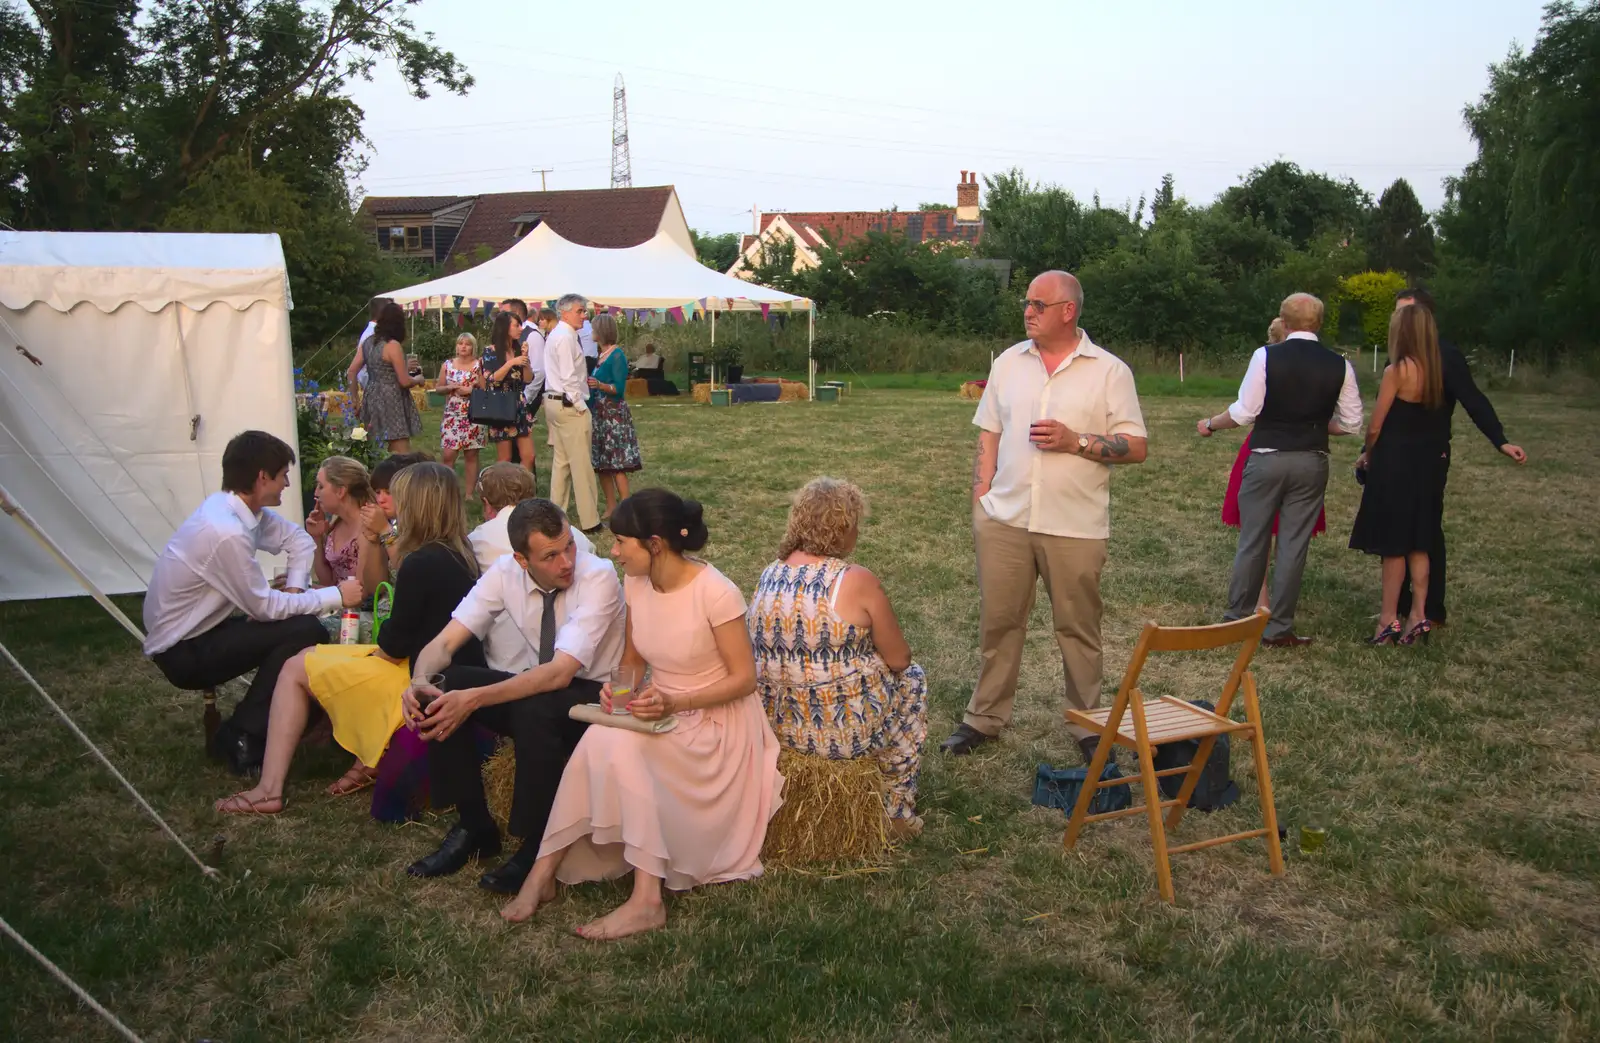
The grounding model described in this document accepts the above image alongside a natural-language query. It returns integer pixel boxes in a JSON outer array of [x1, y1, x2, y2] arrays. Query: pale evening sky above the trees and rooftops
[[355, 0, 1542, 232]]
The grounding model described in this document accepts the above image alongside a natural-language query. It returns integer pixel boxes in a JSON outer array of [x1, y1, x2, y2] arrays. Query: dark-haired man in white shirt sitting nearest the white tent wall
[[144, 430, 362, 774]]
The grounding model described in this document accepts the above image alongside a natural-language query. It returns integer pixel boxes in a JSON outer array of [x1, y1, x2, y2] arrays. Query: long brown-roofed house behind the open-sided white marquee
[[357, 186, 694, 270]]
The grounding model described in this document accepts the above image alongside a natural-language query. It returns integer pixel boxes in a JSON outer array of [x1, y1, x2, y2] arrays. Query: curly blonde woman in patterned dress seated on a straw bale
[[749, 478, 928, 835]]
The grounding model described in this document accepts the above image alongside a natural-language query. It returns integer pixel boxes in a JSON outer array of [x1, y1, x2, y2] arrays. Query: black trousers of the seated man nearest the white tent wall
[[150, 616, 328, 739]]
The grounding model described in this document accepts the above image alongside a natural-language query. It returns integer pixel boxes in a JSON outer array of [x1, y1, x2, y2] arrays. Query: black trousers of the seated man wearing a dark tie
[[427, 667, 600, 848]]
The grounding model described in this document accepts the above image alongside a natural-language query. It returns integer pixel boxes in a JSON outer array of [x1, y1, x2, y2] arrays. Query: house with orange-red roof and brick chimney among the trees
[[728, 170, 984, 278]]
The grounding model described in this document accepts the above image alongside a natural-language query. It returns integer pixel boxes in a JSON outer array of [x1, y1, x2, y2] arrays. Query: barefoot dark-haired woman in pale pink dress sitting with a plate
[[501, 490, 784, 941]]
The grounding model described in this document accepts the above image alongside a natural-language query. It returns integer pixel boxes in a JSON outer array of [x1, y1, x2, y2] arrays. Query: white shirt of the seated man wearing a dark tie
[[453, 537, 627, 681]]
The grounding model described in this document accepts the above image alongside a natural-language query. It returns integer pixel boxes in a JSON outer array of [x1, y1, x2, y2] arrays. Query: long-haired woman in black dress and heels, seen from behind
[[1350, 304, 1450, 645]]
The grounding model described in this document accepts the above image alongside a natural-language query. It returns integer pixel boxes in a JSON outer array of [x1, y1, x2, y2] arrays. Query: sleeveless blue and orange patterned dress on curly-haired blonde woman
[[749, 558, 928, 819]]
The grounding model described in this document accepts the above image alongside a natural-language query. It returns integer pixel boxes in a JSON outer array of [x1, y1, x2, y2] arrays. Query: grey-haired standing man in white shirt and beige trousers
[[544, 293, 600, 536]]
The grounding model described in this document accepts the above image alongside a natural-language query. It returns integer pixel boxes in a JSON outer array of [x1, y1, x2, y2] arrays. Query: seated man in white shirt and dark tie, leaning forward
[[402, 499, 626, 894]]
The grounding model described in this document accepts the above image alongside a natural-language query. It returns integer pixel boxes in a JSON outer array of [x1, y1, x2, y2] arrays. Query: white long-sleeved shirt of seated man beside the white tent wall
[[144, 493, 342, 656]]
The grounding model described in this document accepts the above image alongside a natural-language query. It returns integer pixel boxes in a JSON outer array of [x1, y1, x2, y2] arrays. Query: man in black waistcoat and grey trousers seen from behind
[[1197, 293, 1362, 648]]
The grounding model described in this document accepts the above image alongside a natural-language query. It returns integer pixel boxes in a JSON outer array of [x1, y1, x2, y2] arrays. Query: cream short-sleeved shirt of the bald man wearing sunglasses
[[973, 330, 1146, 539]]
